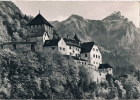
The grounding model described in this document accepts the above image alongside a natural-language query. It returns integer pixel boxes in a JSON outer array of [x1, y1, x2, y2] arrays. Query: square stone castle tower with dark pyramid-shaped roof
[[27, 13, 53, 51]]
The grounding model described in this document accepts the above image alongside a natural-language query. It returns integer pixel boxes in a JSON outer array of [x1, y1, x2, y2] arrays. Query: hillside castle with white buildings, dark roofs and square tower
[[0, 13, 112, 82]]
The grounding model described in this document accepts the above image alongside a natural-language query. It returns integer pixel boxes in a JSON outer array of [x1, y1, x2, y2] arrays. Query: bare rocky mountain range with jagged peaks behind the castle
[[52, 11, 140, 68]]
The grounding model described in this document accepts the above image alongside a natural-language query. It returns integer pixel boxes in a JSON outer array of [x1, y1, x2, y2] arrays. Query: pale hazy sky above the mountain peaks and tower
[[13, 0, 139, 27]]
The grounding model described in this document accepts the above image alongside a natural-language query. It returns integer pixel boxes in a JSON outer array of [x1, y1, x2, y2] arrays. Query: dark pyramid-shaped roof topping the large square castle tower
[[27, 13, 53, 27]]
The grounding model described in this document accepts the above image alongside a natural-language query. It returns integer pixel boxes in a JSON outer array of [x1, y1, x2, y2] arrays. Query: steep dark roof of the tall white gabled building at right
[[81, 42, 95, 53]]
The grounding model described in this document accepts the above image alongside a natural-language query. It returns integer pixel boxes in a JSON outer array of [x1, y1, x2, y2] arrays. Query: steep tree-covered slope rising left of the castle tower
[[0, 1, 31, 43]]
